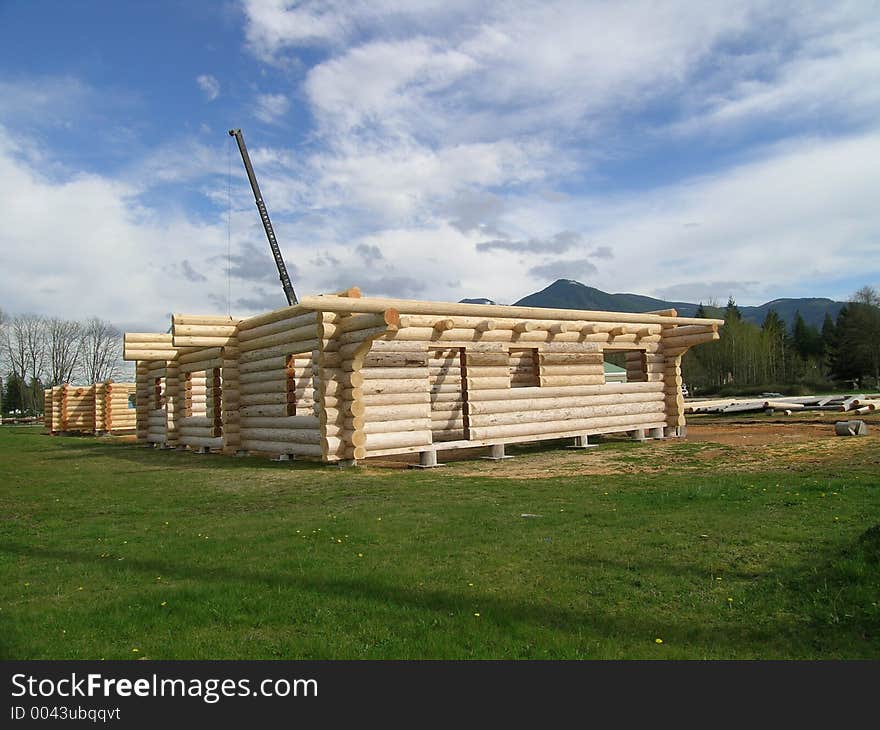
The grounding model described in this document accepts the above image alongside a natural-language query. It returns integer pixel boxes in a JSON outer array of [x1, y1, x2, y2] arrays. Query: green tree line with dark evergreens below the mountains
[[682, 286, 880, 394]]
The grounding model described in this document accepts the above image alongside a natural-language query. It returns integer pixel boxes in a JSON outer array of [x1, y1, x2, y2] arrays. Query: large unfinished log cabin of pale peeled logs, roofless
[[124, 288, 723, 466]]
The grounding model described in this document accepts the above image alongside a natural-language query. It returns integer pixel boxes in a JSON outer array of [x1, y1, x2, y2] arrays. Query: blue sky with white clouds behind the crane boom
[[0, 0, 880, 329]]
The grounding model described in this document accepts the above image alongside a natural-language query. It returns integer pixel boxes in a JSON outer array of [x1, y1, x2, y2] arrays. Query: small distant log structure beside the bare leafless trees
[[43, 380, 137, 434]]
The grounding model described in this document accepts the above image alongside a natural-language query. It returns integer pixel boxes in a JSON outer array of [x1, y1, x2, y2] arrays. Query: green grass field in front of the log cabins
[[0, 420, 880, 659]]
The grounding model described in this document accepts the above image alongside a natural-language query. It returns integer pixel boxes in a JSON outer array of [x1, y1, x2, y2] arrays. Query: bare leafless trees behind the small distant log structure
[[0, 309, 126, 414]]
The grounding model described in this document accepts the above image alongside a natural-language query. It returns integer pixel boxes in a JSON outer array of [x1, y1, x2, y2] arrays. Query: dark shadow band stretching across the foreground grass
[[6, 527, 880, 658]]
